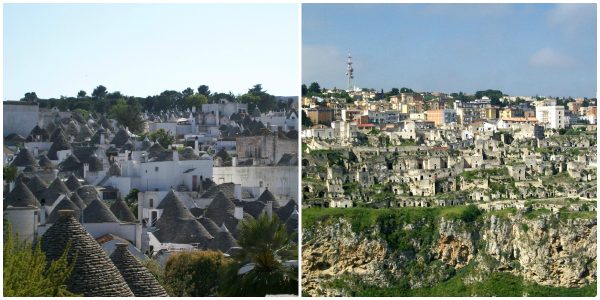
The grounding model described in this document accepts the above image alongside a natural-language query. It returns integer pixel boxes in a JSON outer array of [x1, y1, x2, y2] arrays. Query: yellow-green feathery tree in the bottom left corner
[[3, 219, 76, 297]]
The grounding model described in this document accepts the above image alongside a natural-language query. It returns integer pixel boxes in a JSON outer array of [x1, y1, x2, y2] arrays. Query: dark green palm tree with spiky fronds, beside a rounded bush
[[219, 214, 298, 297]]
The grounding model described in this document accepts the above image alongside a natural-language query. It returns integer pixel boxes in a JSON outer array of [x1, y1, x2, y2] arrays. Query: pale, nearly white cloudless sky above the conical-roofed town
[[3, 4, 300, 100]]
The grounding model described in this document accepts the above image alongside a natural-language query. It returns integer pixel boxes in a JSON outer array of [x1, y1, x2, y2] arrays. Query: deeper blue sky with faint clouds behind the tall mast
[[302, 4, 597, 97]]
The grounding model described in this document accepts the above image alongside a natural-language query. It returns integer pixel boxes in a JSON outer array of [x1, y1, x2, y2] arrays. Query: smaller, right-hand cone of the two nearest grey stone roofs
[[110, 243, 169, 297]]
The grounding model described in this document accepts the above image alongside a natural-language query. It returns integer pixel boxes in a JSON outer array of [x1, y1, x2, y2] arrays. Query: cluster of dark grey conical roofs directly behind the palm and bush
[[154, 188, 298, 253]]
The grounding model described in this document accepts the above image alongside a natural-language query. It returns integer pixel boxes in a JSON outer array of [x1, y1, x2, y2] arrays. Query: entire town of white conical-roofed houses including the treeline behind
[[3, 85, 299, 296]]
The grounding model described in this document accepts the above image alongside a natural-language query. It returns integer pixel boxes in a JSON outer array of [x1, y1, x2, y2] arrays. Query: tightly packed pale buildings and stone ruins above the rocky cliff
[[301, 93, 597, 210]]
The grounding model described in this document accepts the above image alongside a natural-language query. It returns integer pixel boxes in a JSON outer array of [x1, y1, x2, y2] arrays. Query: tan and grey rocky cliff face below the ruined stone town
[[302, 215, 596, 296]]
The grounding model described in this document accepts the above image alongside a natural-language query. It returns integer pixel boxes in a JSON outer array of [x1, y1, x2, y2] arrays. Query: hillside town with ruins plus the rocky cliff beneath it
[[301, 83, 597, 296]]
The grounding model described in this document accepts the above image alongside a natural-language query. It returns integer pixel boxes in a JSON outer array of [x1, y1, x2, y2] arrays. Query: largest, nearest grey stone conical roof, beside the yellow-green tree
[[41, 212, 134, 297]]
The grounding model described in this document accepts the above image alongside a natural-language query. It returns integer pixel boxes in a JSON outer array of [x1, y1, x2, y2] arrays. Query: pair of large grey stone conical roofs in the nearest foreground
[[41, 210, 168, 297]]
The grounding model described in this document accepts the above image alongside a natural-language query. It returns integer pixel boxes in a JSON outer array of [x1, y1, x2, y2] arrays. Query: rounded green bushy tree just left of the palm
[[164, 251, 233, 297]]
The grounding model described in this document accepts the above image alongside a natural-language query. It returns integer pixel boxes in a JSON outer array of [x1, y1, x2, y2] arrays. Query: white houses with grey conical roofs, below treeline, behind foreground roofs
[[3, 100, 298, 296]]
